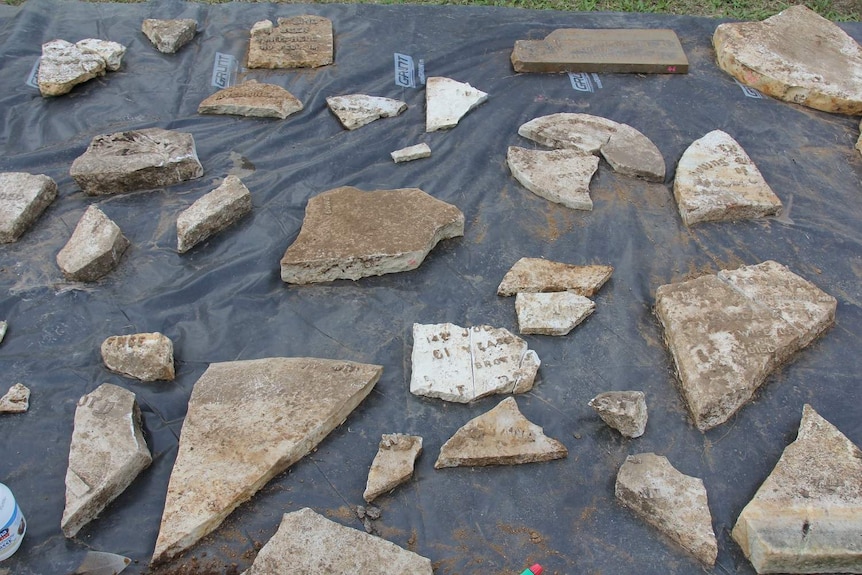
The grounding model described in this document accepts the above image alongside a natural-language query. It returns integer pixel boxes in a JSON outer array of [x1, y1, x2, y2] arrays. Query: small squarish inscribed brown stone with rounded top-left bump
[[248, 14, 334, 68]]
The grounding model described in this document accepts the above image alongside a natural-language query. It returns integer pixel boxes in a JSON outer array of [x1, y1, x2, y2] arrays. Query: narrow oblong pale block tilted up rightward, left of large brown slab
[[177, 176, 251, 254]]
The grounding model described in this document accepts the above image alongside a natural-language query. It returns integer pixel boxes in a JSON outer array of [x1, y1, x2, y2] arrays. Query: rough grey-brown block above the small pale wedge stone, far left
[[70, 128, 204, 196]]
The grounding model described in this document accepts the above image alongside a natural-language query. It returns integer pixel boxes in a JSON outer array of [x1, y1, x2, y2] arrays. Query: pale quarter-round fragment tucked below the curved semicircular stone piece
[[506, 146, 599, 210]]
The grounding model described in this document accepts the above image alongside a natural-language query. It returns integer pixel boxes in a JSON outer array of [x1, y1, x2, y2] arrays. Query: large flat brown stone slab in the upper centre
[[281, 186, 464, 284]]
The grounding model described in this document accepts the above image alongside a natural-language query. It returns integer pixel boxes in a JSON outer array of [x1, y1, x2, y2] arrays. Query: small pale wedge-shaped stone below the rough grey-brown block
[[57, 206, 129, 282]]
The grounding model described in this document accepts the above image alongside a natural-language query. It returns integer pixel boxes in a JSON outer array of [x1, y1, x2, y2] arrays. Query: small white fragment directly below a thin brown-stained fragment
[[515, 291, 596, 335]]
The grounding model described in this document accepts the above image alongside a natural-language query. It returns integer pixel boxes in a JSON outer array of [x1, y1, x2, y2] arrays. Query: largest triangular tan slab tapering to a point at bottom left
[[153, 357, 383, 563]]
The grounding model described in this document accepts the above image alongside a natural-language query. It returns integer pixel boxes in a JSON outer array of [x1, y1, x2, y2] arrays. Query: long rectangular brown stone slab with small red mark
[[511, 28, 688, 74]]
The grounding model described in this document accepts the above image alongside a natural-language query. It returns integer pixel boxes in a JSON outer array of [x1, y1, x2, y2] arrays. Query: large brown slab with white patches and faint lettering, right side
[[655, 261, 837, 430]]
